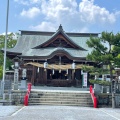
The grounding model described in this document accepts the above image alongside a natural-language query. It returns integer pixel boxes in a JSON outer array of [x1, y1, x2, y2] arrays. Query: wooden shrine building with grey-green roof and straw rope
[[7, 25, 98, 87]]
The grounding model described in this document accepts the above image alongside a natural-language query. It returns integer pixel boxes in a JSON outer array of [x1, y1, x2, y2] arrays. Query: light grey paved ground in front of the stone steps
[[0, 106, 120, 120]]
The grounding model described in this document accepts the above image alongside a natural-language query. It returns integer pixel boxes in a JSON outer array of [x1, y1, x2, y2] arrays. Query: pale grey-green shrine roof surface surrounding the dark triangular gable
[[7, 25, 98, 58]]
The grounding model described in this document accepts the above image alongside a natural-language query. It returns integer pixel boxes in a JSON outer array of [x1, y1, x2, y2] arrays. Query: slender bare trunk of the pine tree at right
[[110, 65, 115, 108]]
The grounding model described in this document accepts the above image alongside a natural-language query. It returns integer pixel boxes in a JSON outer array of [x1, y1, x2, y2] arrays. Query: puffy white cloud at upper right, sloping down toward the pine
[[79, 0, 116, 24]]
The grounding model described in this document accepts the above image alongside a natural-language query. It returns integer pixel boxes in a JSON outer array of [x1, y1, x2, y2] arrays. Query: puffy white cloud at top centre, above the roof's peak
[[41, 0, 77, 21]]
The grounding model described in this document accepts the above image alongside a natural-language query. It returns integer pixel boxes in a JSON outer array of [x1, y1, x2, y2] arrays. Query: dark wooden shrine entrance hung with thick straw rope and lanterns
[[26, 55, 82, 87]]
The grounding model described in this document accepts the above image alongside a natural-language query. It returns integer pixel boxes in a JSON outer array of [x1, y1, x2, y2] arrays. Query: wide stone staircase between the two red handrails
[[29, 91, 93, 107]]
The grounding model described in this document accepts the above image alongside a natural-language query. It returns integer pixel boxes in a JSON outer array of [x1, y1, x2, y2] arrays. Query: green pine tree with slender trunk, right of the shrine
[[87, 32, 120, 108]]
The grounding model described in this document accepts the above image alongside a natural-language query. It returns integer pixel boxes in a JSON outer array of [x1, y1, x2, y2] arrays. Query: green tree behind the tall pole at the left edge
[[0, 33, 17, 78]]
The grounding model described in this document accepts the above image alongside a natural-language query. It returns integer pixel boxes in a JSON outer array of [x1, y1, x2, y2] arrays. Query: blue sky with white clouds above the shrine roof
[[0, 0, 120, 34]]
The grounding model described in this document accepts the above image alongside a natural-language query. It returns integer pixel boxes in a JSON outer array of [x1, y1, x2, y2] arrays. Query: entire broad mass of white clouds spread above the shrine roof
[[14, 0, 120, 32]]
